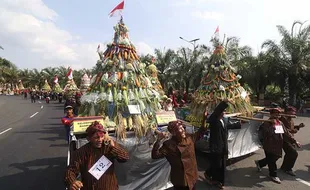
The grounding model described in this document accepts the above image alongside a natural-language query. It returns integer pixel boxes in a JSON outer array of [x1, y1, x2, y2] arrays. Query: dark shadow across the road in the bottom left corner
[[0, 157, 66, 190]]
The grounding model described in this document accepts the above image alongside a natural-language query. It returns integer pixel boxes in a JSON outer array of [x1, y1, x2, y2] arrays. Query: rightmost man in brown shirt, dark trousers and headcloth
[[280, 106, 304, 176]]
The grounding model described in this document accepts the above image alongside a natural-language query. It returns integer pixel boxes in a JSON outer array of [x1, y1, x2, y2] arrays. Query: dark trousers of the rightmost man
[[281, 142, 298, 171]]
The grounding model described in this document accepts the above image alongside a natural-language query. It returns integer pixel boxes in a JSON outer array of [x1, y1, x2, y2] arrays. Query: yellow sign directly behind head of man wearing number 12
[[73, 116, 104, 134]]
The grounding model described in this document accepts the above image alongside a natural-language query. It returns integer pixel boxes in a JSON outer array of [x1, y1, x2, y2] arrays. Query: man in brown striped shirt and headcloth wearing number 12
[[65, 121, 129, 190]]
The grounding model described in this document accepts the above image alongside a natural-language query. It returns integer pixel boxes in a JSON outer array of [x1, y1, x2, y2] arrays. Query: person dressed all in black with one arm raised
[[204, 100, 241, 189]]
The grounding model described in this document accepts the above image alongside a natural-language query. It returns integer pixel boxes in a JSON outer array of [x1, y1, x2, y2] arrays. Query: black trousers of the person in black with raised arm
[[206, 153, 227, 185]]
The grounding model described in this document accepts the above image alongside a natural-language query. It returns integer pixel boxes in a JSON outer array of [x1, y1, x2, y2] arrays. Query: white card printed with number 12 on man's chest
[[88, 155, 112, 180]]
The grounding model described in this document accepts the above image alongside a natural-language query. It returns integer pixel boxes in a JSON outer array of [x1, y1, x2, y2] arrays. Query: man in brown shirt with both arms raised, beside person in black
[[152, 121, 206, 190]]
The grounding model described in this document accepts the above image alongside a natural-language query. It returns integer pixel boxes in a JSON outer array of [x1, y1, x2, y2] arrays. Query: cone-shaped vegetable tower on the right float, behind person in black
[[191, 40, 254, 118]]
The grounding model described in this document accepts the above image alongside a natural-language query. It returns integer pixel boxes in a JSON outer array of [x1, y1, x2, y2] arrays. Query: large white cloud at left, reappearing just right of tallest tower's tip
[[0, 0, 153, 69]]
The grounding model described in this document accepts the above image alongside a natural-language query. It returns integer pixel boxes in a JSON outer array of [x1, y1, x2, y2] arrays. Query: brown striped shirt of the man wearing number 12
[[65, 141, 129, 190]]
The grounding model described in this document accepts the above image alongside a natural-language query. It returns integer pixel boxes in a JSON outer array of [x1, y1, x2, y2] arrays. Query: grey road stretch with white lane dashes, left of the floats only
[[0, 96, 67, 190]]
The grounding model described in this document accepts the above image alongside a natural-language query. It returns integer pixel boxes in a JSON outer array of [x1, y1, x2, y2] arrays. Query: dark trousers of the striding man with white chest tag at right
[[258, 151, 280, 177]]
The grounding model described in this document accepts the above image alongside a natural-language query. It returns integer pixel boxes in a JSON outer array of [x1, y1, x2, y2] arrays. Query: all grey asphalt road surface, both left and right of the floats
[[0, 96, 310, 190]]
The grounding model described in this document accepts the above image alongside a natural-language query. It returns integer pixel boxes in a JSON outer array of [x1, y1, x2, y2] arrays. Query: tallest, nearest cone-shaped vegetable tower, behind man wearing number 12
[[79, 19, 161, 139]]
